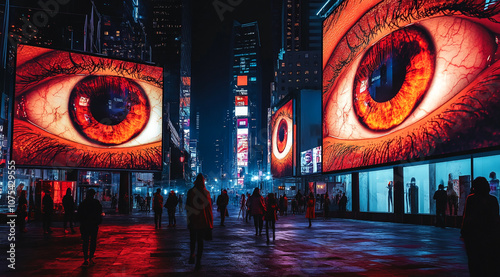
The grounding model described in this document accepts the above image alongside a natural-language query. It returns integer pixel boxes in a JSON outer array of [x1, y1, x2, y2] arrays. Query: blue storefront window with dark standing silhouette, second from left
[[403, 164, 432, 214]]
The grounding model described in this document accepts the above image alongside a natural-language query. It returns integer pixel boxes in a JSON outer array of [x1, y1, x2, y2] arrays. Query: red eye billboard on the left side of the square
[[12, 45, 163, 170]]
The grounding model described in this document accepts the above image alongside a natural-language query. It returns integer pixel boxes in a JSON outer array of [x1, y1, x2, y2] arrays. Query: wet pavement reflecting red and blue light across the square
[[0, 204, 468, 276]]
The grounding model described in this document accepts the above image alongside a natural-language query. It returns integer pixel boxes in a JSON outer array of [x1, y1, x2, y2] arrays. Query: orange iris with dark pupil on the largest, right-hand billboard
[[353, 26, 436, 131]]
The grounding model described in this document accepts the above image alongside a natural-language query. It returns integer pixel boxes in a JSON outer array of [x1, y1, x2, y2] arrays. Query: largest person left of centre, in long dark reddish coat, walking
[[186, 173, 213, 270]]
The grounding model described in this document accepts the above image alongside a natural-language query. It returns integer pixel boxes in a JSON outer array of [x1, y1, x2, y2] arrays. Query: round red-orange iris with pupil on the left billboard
[[69, 76, 150, 145]]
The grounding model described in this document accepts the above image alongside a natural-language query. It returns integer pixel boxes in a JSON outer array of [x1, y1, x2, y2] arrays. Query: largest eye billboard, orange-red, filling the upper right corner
[[322, 0, 500, 171]]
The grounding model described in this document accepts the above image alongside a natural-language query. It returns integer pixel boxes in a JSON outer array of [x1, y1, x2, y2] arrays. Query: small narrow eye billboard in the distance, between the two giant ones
[[271, 100, 295, 177]]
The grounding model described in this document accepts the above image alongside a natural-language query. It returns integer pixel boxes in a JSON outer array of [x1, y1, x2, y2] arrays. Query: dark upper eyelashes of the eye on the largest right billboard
[[324, 1, 492, 92]]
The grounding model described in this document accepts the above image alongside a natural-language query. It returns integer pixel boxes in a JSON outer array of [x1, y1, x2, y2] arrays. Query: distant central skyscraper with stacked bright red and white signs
[[231, 22, 266, 187]]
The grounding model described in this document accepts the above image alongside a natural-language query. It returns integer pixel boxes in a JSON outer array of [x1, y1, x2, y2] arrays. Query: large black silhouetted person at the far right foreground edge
[[461, 177, 500, 277]]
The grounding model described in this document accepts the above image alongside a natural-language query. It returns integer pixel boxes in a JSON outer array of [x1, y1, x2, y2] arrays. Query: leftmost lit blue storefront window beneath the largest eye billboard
[[359, 169, 394, 212]]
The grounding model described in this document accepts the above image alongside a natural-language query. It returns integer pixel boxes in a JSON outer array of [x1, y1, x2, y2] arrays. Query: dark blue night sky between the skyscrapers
[[191, 0, 274, 175]]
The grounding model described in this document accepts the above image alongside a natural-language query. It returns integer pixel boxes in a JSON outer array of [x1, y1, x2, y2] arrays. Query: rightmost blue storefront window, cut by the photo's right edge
[[474, 155, 500, 215]]
